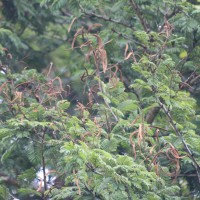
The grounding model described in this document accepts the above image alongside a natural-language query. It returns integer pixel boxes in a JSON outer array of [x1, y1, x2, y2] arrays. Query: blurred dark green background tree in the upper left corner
[[0, 0, 70, 71]]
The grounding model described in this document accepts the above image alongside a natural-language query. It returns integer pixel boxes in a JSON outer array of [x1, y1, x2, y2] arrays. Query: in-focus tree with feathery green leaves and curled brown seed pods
[[0, 0, 200, 199]]
